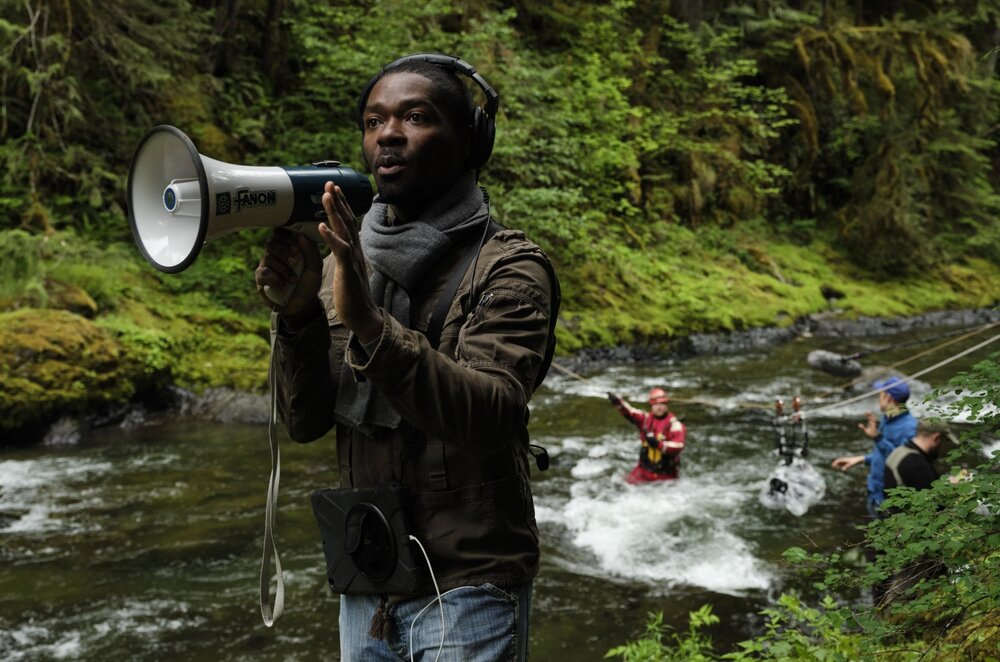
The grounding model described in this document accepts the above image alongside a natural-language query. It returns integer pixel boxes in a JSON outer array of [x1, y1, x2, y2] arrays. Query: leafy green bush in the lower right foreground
[[776, 354, 1000, 660]]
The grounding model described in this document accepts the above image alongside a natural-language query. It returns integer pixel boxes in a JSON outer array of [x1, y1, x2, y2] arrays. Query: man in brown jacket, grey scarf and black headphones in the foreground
[[255, 54, 559, 660]]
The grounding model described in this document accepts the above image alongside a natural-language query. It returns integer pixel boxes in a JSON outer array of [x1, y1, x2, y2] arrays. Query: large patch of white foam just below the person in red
[[536, 436, 774, 595]]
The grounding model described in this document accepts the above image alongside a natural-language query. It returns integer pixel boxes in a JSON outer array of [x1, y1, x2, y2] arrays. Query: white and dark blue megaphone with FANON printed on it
[[128, 124, 374, 273]]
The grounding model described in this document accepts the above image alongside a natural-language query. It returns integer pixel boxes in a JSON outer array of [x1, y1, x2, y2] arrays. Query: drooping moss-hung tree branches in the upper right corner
[[785, 18, 1000, 276]]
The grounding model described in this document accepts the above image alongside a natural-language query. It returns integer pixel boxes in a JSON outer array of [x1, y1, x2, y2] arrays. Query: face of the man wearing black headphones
[[362, 72, 468, 220]]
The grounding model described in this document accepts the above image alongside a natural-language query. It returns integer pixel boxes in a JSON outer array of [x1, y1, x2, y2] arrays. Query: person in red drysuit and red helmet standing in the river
[[608, 388, 687, 484]]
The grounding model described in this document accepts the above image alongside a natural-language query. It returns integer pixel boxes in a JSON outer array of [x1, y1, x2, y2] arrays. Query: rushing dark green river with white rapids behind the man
[[0, 320, 995, 662]]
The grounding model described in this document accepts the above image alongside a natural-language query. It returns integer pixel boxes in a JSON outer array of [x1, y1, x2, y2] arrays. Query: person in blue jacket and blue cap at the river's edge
[[833, 377, 917, 519]]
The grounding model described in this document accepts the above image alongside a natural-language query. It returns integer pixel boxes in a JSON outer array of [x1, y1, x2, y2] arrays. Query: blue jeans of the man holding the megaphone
[[340, 583, 531, 662]]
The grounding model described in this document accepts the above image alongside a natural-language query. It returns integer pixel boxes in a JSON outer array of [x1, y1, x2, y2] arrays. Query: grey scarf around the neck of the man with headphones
[[335, 172, 488, 436]]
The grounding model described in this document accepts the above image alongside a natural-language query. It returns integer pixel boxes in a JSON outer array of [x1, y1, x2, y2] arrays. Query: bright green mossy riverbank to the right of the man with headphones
[[558, 224, 1000, 353]]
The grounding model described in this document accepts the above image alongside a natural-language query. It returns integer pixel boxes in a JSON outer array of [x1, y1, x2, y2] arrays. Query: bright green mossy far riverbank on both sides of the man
[[0, 228, 1000, 440]]
